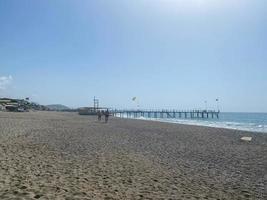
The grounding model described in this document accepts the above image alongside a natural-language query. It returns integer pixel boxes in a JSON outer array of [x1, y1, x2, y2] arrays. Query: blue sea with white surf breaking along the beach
[[118, 112, 267, 133]]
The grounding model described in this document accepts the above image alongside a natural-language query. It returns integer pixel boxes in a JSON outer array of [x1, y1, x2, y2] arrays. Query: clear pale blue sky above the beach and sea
[[0, 0, 267, 112]]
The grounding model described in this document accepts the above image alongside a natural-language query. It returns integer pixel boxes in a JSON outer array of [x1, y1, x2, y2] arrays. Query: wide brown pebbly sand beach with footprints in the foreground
[[0, 112, 267, 200]]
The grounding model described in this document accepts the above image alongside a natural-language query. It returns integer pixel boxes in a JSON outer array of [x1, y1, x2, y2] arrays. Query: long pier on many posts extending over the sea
[[110, 109, 220, 119]]
